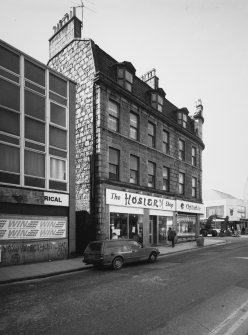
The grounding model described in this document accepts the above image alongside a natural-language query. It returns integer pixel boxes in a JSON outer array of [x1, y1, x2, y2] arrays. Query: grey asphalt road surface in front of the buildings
[[0, 238, 248, 335]]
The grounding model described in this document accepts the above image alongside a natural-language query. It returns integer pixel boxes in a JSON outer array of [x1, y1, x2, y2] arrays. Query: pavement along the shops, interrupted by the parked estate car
[[0, 237, 234, 285]]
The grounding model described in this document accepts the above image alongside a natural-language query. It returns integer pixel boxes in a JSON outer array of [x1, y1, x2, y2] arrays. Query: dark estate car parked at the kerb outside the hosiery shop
[[83, 239, 160, 270]]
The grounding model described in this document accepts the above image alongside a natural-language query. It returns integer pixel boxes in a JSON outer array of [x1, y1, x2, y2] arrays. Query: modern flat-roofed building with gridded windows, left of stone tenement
[[0, 40, 76, 266]]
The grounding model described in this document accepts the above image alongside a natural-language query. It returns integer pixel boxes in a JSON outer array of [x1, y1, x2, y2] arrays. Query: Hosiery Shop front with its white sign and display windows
[[106, 189, 175, 245]]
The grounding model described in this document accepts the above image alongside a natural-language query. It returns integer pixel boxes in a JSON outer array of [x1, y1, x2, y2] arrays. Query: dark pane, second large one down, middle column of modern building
[[25, 90, 45, 121]]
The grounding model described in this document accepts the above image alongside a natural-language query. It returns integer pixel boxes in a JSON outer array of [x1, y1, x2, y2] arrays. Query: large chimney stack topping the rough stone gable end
[[49, 7, 82, 59]]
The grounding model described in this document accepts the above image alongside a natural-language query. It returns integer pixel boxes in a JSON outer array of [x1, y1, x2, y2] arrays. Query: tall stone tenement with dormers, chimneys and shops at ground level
[[49, 8, 204, 244]]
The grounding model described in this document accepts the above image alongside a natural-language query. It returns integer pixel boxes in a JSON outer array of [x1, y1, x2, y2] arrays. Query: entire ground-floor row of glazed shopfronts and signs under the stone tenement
[[106, 189, 204, 245]]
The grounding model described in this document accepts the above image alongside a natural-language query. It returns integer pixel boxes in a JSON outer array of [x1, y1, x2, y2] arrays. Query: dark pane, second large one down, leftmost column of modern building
[[0, 78, 20, 111]]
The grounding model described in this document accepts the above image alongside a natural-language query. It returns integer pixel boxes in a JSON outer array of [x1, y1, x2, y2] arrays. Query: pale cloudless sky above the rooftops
[[0, 0, 248, 199]]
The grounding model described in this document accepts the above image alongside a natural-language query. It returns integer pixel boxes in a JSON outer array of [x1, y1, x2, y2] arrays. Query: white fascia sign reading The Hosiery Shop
[[106, 189, 175, 211]]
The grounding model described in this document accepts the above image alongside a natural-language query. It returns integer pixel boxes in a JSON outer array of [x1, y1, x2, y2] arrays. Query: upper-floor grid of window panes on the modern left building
[[0, 47, 68, 191]]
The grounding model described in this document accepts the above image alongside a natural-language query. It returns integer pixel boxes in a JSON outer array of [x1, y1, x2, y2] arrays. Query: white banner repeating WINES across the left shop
[[0, 219, 67, 241]]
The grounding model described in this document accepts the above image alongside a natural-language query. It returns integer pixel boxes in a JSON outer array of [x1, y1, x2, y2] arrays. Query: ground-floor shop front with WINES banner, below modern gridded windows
[[0, 187, 73, 267]]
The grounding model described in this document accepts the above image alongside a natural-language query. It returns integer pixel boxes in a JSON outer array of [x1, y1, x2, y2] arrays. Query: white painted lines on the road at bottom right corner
[[208, 301, 248, 335]]
